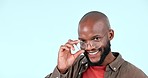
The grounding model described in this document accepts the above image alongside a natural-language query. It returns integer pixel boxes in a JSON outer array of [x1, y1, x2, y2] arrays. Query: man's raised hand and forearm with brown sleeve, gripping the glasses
[[45, 40, 84, 78]]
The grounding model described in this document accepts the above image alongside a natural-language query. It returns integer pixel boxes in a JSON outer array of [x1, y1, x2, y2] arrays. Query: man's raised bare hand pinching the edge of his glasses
[[58, 40, 84, 73]]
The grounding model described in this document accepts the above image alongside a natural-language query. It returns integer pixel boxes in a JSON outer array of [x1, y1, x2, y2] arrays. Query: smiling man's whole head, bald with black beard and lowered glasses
[[78, 11, 114, 66]]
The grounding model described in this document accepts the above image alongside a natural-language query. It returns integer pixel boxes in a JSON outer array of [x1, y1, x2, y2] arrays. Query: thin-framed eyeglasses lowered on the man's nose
[[80, 32, 107, 48]]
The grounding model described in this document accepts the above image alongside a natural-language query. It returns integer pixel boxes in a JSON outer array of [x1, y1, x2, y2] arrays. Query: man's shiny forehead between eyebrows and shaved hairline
[[78, 21, 107, 38]]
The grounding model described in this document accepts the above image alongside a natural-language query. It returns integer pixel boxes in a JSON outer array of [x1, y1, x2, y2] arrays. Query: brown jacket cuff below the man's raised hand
[[45, 67, 68, 78]]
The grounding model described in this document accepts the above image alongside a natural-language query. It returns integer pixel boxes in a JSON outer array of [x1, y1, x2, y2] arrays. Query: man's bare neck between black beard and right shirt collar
[[102, 52, 116, 66]]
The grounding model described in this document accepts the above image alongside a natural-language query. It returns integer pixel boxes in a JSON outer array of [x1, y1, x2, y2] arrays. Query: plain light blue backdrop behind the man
[[0, 0, 148, 78]]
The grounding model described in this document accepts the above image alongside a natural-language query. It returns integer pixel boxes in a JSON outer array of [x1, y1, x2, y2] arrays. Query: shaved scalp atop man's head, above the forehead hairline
[[79, 11, 110, 29]]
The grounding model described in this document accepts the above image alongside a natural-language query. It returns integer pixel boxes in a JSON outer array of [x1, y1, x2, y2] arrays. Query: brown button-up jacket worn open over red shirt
[[45, 53, 148, 78]]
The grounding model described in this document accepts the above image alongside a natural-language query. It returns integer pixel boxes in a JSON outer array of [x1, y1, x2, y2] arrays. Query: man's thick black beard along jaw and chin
[[84, 41, 111, 66]]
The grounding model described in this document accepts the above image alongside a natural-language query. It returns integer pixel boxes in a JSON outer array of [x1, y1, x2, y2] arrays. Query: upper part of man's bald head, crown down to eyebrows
[[78, 11, 113, 39]]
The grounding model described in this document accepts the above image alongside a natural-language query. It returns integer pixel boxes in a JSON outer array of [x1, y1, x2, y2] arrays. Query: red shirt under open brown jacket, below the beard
[[82, 66, 106, 78]]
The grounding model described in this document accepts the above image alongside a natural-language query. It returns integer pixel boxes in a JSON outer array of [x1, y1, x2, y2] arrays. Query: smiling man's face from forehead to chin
[[78, 21, 110, 63]]
